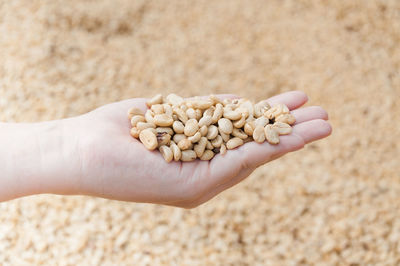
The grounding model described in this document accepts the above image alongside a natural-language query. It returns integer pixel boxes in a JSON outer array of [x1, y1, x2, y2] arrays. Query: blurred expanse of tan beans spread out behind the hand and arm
[[0, 0, 400, 266]]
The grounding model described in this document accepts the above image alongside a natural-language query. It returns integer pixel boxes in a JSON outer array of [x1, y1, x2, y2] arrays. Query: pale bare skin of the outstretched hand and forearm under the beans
[[0, 91, 332, 208]]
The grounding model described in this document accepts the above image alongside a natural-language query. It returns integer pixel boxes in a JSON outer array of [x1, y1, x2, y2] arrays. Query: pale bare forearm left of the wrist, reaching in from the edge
[[0, 120, 79, 201]]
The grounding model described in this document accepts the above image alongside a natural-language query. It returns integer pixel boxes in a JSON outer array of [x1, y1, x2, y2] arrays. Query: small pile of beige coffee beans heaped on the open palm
[[128, 94, 295, 162]]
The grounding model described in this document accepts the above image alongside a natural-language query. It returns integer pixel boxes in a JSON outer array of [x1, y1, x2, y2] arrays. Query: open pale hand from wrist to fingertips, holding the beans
[[72, 91, 331, 208]]
